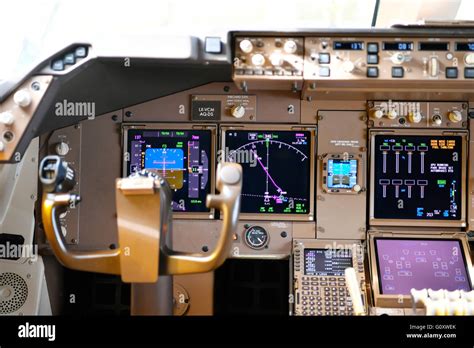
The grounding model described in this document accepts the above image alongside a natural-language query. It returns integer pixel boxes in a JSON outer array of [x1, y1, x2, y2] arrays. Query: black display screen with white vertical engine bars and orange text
[[373, 135, 462, 220]]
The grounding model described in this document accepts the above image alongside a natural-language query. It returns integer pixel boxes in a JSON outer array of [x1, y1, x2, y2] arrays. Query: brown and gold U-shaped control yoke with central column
[[39, 156, 242, 283]]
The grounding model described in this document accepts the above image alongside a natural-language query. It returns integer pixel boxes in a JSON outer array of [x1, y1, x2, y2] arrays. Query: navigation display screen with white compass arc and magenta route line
[[225, 130, 312, 214]]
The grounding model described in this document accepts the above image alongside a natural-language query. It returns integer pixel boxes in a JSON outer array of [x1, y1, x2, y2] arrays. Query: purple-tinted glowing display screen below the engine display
[[375, 238, 471, 295]]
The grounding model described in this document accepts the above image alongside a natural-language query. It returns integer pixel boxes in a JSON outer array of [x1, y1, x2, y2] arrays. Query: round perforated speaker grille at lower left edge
[[0, 273, 28, 314]]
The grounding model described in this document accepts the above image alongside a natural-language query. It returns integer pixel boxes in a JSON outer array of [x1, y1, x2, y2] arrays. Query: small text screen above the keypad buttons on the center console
[[304, 249, 352, 276]]
